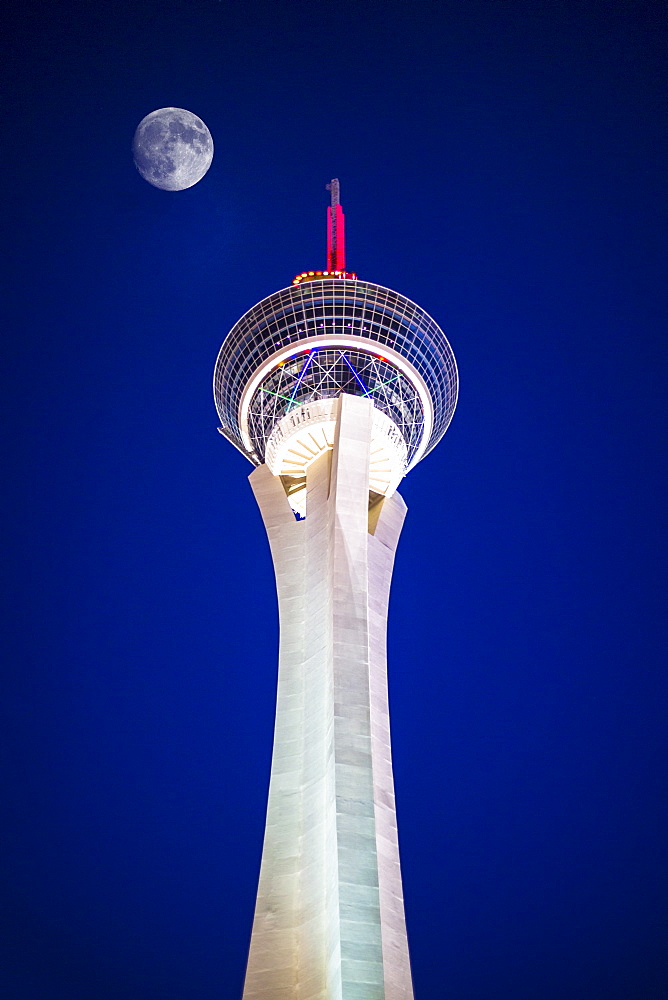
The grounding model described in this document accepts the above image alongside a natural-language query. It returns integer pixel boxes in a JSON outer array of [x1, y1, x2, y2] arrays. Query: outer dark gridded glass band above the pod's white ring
[[214, 279, 458, 462]]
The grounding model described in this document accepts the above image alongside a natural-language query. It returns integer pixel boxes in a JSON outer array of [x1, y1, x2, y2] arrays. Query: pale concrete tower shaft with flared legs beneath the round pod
[[244, 394, 413, 1000]]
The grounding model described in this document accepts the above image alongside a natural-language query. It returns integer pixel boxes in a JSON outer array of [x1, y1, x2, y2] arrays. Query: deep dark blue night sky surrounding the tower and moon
[[0, 0, 668, 1000]]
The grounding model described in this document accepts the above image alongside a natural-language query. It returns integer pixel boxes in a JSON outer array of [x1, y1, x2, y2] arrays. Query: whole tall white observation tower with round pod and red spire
[[214, 180, 457, 1000]]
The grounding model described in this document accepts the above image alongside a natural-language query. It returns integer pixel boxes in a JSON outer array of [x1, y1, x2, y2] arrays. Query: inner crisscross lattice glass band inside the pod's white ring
[[248, 347, 424, 462]]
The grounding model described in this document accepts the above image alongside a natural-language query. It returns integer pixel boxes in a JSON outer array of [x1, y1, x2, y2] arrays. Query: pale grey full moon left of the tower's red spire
[[132, 108, 213, 191]]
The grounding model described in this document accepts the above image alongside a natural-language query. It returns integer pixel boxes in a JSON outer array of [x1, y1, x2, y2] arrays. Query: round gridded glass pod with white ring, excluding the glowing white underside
[[214, 279, 458, 469]]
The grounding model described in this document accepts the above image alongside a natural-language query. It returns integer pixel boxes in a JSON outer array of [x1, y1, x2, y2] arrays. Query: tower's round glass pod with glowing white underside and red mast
[[214, 182, 458, 513]]
